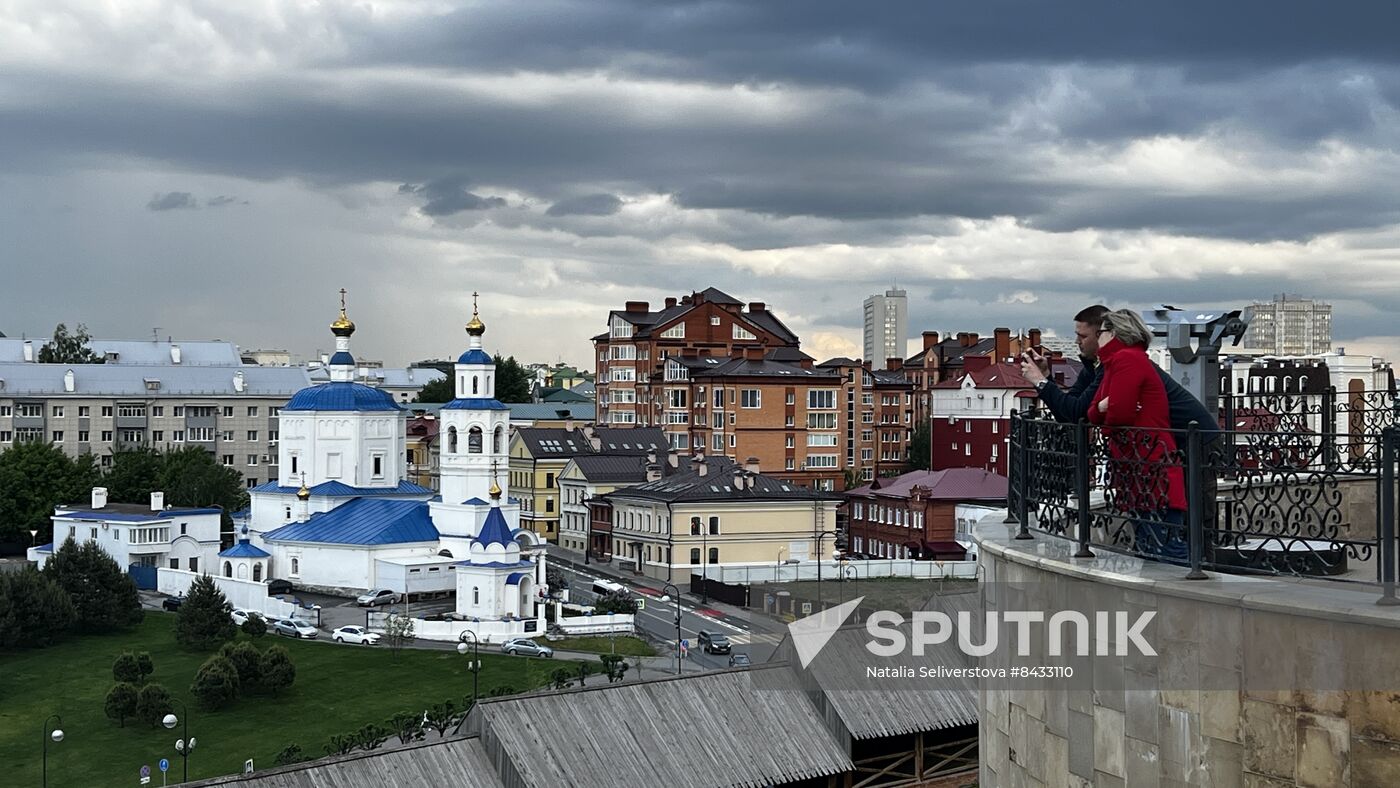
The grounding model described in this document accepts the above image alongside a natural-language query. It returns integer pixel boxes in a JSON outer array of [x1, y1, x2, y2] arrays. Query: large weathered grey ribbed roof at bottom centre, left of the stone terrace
[[466, 668, 854, 788]]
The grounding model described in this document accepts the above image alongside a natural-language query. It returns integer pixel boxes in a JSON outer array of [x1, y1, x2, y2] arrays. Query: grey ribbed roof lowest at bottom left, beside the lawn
[[189, 736, 504, 788]]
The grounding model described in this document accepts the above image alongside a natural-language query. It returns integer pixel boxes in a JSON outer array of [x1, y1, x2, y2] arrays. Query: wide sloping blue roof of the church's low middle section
[[263, 498, 438, 546]]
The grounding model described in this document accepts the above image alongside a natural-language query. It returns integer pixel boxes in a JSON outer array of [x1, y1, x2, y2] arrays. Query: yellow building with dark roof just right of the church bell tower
[[510, 425, 666, 542]]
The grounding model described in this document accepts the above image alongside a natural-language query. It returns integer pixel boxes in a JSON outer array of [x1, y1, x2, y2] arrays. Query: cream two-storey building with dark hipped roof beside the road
[[603, 456, 841, 581]]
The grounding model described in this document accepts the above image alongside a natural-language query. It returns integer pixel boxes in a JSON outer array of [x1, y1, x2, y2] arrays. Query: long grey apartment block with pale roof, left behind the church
[[0, 361, 311, 487]]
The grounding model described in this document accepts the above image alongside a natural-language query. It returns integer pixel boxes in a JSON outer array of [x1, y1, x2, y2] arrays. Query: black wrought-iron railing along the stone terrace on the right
[[1007, 389, 1400, 605]]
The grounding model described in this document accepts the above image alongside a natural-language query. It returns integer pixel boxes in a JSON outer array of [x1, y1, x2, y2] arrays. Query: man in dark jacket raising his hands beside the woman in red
[[1021, 304, 1219, 442]]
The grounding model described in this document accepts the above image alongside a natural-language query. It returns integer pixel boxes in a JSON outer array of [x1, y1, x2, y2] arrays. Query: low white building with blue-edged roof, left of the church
[[29, 487, 224, 572]]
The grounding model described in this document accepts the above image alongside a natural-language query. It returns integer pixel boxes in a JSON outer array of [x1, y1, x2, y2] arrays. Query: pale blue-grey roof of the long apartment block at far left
[[0, 363, 311, 399]]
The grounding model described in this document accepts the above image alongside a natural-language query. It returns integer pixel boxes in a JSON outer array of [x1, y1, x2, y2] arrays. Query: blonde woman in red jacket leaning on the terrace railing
[[1088, 309, 1187, 560]]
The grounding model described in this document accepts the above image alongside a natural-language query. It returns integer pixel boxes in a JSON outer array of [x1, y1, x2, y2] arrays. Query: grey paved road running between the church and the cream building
[[553, 560, 781, 670]]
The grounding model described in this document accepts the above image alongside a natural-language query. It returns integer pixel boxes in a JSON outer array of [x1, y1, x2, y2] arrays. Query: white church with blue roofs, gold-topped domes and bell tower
[[240, 294, 546, 634]]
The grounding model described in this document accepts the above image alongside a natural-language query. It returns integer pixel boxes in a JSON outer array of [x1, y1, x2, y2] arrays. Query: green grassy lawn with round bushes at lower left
[[0, 612, 573, 787]]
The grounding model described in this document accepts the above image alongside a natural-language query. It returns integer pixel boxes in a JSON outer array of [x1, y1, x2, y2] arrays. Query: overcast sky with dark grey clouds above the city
[[0, 0, 1400, 367]]
